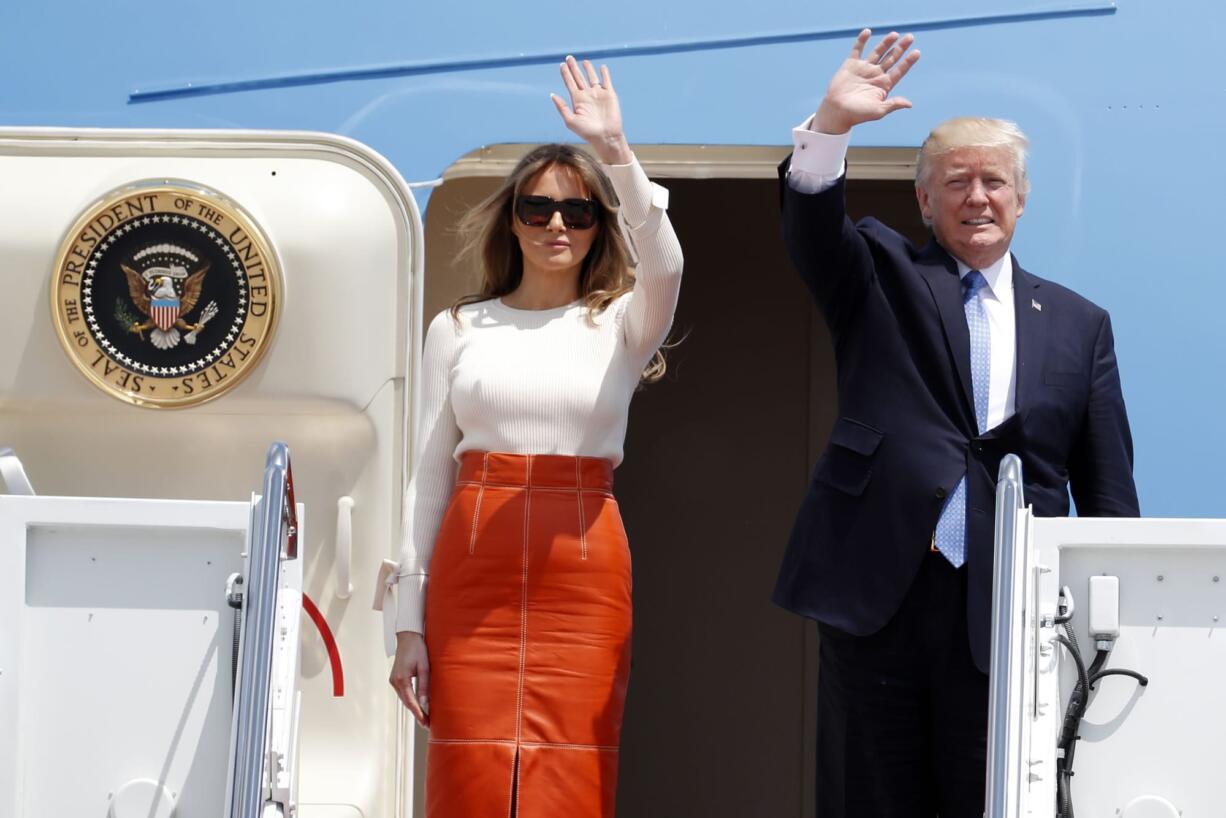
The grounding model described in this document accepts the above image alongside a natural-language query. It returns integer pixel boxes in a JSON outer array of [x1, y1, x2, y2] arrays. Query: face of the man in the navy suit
[[916, 147, 1026, 270]]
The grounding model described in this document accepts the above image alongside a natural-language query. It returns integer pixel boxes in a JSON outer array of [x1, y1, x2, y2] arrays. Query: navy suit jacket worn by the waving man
[[774, 157, 1140, 672]]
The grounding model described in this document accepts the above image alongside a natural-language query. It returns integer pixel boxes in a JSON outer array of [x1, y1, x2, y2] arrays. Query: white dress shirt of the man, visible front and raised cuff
[[787, 117, 1018, 432]]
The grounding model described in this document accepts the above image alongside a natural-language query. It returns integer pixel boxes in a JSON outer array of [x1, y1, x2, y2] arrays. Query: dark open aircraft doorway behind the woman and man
[[418, 146, 924, 818]]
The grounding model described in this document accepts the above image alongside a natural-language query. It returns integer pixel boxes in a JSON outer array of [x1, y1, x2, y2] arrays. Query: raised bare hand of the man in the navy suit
[[813, 28, 920, 134]]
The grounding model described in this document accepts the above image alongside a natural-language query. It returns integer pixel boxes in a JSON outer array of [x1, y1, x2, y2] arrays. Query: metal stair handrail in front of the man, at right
[[984, 455, 1024, 818]]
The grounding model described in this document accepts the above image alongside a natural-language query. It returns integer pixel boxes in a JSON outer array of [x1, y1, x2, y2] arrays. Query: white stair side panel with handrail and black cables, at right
[[986, 455, 1226, 818]]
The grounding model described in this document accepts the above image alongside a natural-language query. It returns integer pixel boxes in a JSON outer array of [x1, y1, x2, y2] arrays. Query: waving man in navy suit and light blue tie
[[775, 31, 1139, 818]]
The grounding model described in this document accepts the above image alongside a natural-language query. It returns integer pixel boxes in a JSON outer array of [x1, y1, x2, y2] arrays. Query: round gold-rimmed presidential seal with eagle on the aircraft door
[[51, 183, 282, 407]]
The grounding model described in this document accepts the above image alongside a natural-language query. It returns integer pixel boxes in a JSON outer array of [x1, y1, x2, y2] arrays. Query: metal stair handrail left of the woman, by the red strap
[[227, 443, 297, 818]]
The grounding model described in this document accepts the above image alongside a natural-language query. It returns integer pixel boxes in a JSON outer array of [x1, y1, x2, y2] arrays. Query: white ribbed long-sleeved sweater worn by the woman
[[396, 161, 682, 633]]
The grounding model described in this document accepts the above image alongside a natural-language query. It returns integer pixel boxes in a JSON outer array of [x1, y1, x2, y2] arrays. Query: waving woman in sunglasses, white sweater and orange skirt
[[390, 58, 682, 818]]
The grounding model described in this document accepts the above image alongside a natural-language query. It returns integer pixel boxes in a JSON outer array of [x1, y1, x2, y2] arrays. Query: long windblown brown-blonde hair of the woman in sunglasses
[[451, 143, 664, 384]]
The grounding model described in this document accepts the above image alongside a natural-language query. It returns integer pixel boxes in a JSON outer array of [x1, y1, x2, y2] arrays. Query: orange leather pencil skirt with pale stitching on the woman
[[425, 451, 631, 818]]
